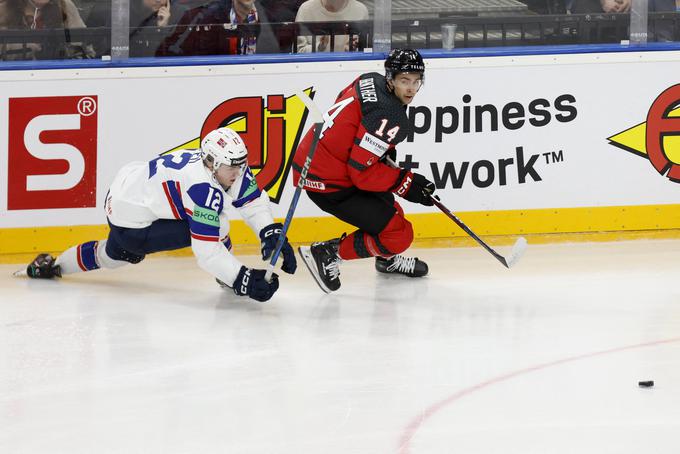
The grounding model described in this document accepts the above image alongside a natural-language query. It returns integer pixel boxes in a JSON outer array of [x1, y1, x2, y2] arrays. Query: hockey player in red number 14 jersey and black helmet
[[293, 49, 435, 293]]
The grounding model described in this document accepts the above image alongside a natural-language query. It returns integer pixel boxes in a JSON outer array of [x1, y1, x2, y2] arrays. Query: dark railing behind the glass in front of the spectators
[[0, 13, 680, 60]]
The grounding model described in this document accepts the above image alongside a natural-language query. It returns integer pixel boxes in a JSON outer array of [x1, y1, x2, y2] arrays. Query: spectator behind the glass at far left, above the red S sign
[[2, 0, 95, 60]]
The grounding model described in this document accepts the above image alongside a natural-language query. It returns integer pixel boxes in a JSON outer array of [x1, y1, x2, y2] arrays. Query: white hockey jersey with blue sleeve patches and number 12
[[105, 150, 274, 285]]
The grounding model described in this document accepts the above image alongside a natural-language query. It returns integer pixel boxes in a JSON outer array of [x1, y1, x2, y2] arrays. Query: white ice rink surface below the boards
[[0, 240, 680, 454]]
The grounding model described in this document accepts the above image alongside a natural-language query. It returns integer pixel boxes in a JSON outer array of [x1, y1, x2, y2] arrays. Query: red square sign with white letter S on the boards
[[7, 96, 97, 210]]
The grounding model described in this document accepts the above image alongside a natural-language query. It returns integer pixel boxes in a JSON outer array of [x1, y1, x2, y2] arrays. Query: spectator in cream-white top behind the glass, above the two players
[[295, 0, 368, 52]]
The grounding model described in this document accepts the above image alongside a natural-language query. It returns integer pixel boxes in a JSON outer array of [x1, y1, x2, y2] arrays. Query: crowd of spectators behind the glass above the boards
[[0, 0, 680, 64]]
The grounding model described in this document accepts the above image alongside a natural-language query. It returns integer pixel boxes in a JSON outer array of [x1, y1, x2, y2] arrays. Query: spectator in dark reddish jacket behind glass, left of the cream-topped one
[[156, 0, 259, 56]]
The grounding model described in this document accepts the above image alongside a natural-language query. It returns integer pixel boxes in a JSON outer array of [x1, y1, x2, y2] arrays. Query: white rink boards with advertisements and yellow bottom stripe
[[0, 51, 680, 254]]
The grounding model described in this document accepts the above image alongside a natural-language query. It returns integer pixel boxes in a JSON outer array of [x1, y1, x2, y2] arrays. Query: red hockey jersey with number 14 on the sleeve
[[293, 73, 410, 192]]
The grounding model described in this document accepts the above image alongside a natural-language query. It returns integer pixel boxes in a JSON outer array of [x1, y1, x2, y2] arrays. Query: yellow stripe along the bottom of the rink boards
[[0, 205, 680, 263]]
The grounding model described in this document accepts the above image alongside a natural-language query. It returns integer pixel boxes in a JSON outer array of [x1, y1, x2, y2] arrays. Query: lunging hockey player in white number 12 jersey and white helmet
[[21, 128, 297, 301]]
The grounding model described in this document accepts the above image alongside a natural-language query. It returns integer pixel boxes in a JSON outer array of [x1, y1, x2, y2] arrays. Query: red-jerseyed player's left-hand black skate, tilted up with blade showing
[[298, 238, 340, 293]]
